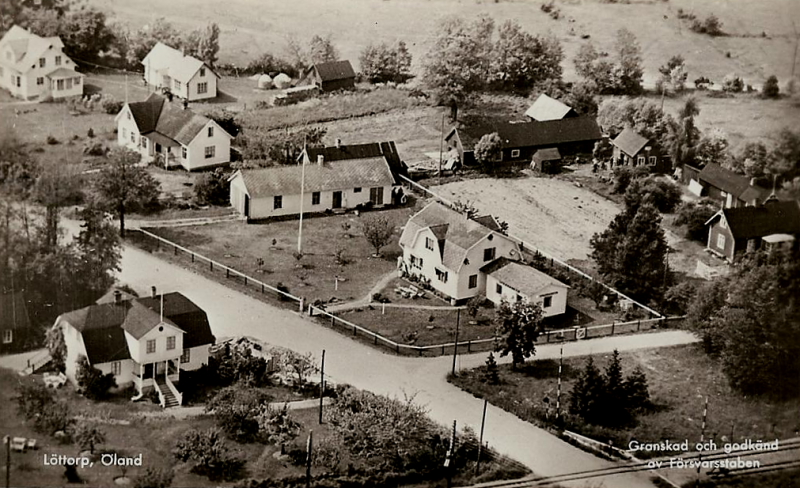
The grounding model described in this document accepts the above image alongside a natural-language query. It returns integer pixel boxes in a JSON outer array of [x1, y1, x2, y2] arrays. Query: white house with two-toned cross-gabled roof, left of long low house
[[114, 93, 233, 171]]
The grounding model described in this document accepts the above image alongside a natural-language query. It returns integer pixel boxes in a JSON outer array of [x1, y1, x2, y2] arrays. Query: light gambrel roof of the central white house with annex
[[400, 202, 500, 272]]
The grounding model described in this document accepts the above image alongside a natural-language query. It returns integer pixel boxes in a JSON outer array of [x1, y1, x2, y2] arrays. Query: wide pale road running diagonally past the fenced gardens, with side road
[[114, 247, 694, 488]]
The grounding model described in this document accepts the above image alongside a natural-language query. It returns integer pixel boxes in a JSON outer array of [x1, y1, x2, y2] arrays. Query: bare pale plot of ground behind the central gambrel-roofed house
[[431, 176, 620, 260]]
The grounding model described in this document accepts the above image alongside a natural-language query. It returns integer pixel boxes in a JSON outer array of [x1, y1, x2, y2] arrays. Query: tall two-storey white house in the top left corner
[[0, 25, 83, 100]]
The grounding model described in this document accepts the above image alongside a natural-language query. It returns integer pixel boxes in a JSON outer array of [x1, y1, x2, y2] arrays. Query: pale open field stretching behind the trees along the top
[[89, 0, 800, 84]]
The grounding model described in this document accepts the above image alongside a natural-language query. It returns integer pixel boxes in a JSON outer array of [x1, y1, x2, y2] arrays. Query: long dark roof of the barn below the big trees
[[456, 117, 602, 150]]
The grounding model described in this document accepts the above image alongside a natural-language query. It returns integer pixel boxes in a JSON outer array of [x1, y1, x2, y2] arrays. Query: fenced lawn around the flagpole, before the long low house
[[134, 204, 416, 303]]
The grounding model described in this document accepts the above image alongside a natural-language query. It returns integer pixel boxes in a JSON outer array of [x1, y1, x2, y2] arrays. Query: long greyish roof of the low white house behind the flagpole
[[240, 157, 395, 198]]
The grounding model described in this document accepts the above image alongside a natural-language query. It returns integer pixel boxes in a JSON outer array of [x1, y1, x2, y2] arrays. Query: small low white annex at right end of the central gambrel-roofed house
[[484, 259, 569, 317]]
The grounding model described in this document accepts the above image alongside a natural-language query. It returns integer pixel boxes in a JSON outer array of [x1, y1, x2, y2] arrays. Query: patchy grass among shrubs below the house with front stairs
[[0, 369, 328, 487]]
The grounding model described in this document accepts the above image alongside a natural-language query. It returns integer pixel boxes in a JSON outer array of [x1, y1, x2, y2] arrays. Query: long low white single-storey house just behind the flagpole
[[230, 148, 399, 220]]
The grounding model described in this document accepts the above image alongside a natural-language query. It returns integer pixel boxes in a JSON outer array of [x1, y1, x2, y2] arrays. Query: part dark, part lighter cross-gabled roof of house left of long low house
[[123, 93, 231, 145]]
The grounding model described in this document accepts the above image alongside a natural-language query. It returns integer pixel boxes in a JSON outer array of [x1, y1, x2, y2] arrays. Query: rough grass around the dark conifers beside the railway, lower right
[[452, 345, 800, 458]]
